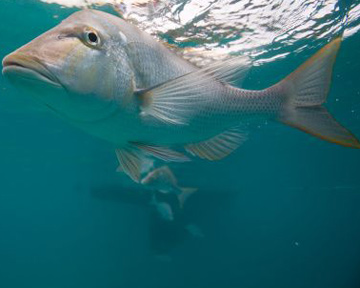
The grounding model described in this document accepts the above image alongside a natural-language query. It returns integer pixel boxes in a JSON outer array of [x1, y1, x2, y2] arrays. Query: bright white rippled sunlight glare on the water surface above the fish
[[41, 0, 360, 62]]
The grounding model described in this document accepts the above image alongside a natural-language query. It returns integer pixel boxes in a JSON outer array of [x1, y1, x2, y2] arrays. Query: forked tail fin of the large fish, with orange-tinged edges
[[275, 37, 360, 149]]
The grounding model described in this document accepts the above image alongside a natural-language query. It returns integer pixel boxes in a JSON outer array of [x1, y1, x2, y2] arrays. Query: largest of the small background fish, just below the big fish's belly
[[141, 166, 198, 208]]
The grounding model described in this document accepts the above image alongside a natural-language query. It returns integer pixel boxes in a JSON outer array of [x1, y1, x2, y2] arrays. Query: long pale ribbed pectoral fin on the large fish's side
[[135, 56, 250, 125]]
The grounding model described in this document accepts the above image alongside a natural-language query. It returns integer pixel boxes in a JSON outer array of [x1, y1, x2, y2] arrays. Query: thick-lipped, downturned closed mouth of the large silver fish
[[2, 53, 61, 87]]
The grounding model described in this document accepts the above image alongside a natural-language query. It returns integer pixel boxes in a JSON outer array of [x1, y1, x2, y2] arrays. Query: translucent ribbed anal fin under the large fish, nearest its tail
[[185, 127, 247, 161]]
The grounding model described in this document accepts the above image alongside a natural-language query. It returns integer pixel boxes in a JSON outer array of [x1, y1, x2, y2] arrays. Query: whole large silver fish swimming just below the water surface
[[3, 10, 360, 181]]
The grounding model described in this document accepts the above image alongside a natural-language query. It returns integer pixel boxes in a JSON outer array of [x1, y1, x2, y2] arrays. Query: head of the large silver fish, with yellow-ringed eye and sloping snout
[[2, 10, 133, 121]]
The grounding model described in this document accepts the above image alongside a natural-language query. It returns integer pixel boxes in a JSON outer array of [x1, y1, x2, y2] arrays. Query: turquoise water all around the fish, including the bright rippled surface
[[0, 0, 360, 288]]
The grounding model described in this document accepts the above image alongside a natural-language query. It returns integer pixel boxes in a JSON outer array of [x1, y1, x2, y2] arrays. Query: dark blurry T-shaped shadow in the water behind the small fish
[[90, 185, 239, 261]]
